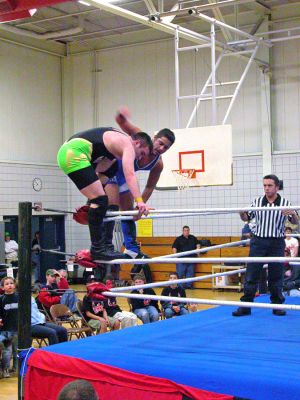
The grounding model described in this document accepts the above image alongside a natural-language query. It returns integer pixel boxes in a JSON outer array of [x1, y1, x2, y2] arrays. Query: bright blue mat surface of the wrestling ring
[[25, 296, 300, 400]]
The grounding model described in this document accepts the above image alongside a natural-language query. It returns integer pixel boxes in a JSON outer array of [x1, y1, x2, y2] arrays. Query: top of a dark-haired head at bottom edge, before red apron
[[57, 379, 99, 400]]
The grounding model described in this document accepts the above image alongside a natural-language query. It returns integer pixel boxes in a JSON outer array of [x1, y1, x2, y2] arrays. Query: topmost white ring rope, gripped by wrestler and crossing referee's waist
[[106, 206, 300, 217]]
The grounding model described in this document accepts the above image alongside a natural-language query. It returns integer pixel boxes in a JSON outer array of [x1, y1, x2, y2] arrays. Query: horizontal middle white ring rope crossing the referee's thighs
[[101, 257, 300, 264]]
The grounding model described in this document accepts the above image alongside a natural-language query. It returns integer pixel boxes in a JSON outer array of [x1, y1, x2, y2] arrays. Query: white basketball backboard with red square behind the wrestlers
[[156, 125, 232, 190]]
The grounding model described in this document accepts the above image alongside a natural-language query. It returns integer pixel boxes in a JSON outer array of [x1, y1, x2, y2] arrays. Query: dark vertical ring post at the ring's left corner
[[18, 202, 32, 400]]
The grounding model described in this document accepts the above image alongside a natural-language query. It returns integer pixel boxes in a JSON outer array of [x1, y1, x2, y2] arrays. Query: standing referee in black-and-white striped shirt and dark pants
[[232, 175, 298, 317]]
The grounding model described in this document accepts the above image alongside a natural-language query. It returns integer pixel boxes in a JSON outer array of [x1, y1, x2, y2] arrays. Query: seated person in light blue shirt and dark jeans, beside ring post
[[31, 297, 68, 345]]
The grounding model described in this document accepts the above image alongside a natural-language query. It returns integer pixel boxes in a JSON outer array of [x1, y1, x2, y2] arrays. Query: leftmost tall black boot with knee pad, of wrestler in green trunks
[[88, 196, 124, 261]]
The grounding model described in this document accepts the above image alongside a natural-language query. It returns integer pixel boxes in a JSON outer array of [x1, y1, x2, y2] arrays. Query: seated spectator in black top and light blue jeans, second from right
[[130, 274, 160, 324]]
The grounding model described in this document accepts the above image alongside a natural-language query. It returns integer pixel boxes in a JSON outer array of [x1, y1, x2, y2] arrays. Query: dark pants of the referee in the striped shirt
[[241, 236, 285, 304]]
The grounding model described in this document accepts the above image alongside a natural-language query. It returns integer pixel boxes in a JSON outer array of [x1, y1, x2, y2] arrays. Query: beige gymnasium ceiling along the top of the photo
[[0, 0, 300, 53]]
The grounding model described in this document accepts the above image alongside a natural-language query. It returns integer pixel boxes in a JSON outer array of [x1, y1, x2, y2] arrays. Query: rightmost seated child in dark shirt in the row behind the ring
[[160, 272, 189, 319]]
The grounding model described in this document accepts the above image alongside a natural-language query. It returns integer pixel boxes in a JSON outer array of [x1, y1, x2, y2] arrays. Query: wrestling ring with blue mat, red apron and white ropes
[[17, 207, 300, 400]]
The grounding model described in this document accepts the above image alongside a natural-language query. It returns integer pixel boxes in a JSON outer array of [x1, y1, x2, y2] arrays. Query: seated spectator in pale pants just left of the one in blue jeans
[[104, 277, 137, 329]]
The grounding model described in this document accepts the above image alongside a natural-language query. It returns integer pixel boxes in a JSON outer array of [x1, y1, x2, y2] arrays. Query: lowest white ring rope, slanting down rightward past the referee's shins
[[102, 292, 300, 311]]
